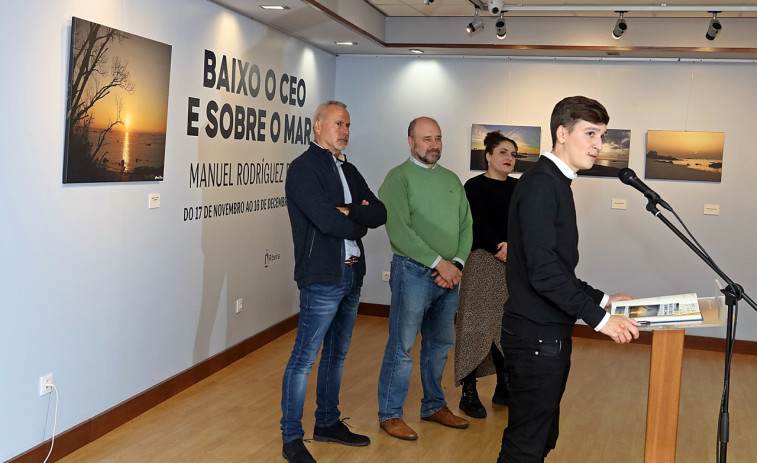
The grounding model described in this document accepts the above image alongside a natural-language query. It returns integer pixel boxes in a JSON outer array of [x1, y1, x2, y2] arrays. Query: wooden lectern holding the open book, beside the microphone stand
[[643, 296, 727, 463]]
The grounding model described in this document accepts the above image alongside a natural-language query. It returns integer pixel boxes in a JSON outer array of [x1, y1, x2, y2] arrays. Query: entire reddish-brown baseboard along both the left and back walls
[[5, 302, 757, 463]]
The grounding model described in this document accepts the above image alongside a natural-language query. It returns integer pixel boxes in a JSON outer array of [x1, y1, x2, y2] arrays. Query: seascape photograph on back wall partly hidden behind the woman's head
[[470, 124, 541, 172]]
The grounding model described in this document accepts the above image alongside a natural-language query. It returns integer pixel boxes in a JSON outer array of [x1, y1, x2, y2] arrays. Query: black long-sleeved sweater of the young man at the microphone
[[502, 156, 606, 339]]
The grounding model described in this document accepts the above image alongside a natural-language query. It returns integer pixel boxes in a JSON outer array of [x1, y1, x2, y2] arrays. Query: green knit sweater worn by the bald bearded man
[[379, 159, 473, 267]]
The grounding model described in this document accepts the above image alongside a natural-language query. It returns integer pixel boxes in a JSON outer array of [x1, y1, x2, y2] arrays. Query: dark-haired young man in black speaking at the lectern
[[497, 96, 639, 463]]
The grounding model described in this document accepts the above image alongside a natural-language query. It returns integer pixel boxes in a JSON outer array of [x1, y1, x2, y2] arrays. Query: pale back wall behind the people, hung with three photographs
[[336, 57, 757, 340]]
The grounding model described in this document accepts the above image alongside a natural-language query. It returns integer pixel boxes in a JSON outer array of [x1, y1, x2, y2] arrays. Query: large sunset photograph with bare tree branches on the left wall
[[63, 18, 171, 183]]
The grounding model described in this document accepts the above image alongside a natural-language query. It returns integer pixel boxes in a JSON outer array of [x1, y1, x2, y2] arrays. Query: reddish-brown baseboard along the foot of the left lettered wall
[[5, 315, 299, 463]]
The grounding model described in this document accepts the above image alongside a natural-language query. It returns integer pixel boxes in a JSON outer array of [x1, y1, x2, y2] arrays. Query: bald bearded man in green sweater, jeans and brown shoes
[[378, 117, 473, 440]]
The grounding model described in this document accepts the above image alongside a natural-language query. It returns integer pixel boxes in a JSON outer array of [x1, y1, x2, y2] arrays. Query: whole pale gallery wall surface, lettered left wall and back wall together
[[0, 0, 757, 461]]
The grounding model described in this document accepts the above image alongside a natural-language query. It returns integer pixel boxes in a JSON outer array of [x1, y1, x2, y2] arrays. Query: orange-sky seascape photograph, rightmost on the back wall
[[644, 130, 725, 182]]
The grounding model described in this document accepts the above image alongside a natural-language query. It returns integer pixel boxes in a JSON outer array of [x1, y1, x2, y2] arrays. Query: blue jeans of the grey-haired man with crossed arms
[[281, 265, 360, 443]]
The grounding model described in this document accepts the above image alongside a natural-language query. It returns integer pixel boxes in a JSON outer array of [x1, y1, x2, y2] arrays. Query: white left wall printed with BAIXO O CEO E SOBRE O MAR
[[0, 0, 336, 461]]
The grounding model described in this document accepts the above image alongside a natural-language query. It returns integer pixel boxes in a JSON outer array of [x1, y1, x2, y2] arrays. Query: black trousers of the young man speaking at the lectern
[[497, 331, 573, 463]]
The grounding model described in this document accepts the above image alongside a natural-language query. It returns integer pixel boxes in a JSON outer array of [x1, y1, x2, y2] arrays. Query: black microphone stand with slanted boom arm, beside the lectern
[[645, 195, 757, 463]]
